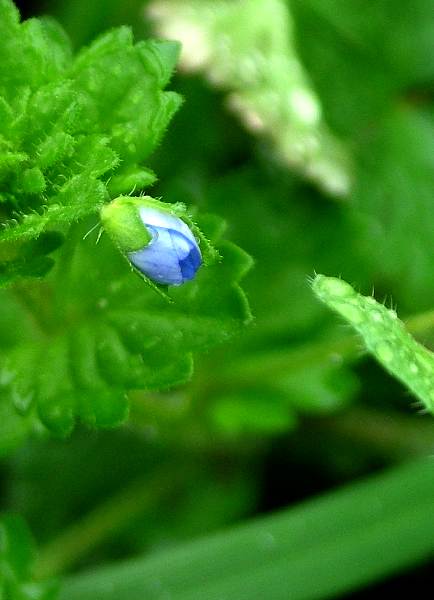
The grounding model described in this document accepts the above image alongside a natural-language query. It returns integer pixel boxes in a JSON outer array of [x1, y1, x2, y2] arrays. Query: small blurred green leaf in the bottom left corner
[[0, 515, 57, 600]]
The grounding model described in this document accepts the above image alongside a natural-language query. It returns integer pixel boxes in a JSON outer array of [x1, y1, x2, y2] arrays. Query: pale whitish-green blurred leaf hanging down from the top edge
[[149, 0, 351, 197]]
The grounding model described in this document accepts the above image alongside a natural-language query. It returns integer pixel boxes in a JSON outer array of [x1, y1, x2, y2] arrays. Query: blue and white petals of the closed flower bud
[[127, 207, 202, 285]]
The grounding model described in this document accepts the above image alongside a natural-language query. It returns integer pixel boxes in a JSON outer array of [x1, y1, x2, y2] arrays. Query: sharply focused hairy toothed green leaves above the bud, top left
[[0, 5, 181, 283]]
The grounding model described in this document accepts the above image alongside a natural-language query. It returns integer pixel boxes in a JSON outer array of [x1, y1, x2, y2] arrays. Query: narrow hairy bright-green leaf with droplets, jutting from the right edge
[[312, 275, 434, 412]]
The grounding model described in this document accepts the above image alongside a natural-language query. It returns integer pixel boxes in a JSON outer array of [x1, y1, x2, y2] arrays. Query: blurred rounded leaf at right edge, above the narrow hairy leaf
[[354, 106, 434, 311]]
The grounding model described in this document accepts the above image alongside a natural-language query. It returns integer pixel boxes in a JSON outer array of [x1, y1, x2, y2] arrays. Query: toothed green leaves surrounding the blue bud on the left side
[[0, 0, 250, 440]]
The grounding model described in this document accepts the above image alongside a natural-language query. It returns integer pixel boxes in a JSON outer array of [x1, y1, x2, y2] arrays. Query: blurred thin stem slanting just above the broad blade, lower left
[[34, 468, 183, 579]]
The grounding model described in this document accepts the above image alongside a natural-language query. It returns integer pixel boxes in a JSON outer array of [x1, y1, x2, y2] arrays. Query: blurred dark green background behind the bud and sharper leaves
[[0, 0, 434, 598]]
